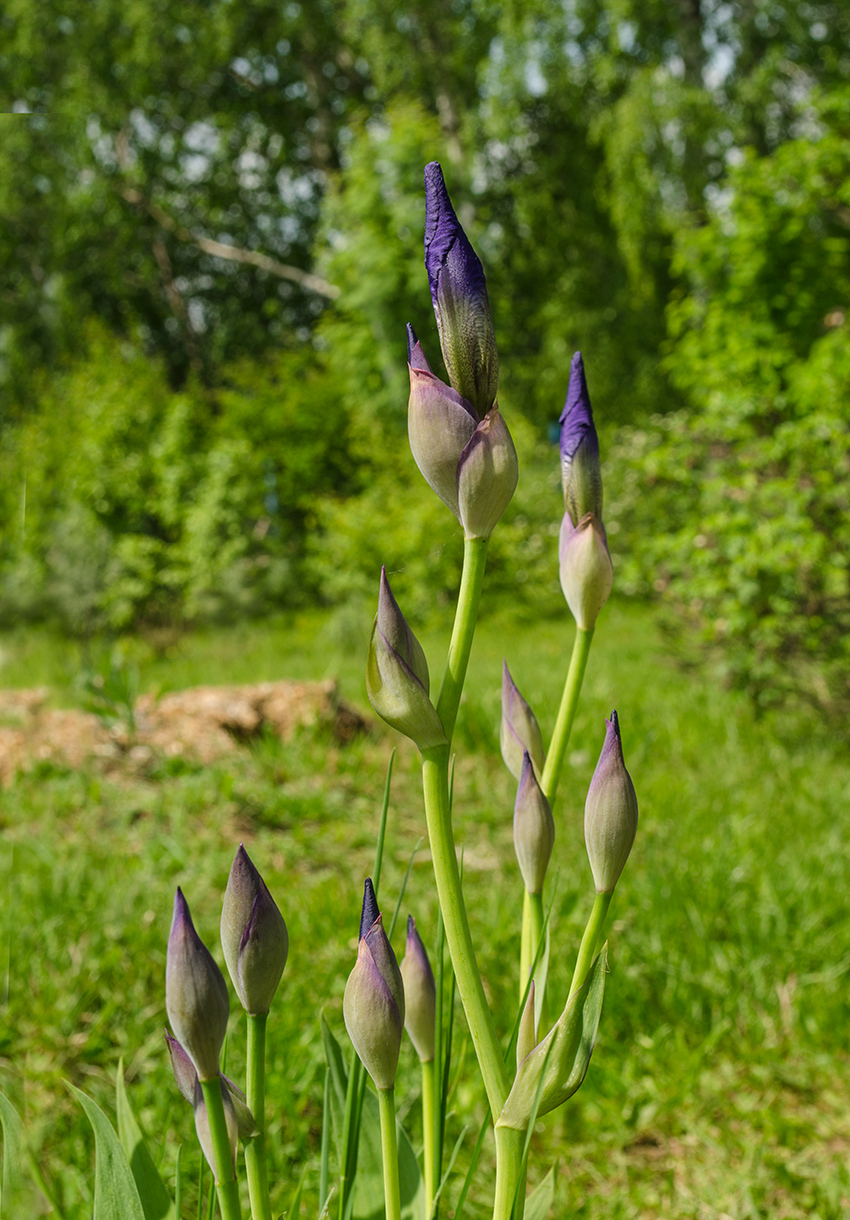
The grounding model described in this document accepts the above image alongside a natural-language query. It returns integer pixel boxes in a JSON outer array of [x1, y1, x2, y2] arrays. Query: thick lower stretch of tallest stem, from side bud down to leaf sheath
[[422, 745, 510, 1114]]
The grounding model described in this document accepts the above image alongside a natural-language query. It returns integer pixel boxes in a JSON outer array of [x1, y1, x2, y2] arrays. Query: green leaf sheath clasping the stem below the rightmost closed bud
[[496, 946, 607, 1131]]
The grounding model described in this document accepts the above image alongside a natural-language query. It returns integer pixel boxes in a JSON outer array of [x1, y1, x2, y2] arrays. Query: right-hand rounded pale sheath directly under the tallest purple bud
[[457, 406, 520, 538]]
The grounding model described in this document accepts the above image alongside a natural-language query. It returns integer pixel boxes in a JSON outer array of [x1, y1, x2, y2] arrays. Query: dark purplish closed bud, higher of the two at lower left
[[221, 843, 289, 1016]]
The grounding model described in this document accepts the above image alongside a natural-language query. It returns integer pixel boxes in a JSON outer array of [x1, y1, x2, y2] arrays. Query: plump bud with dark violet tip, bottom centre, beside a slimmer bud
[[343, 880, 405, 1089]]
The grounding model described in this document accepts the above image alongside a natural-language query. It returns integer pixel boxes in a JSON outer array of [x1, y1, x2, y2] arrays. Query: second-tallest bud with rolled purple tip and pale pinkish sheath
[[559, 351, 613, 631]]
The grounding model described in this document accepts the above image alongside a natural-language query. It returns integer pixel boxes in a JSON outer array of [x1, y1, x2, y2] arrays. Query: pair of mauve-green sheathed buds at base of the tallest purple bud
[[407, 326, 518, 538]]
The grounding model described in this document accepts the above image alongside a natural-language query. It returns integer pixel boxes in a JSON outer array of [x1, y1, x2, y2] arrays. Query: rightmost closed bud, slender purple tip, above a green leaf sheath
[[584, 711, 638, 894]]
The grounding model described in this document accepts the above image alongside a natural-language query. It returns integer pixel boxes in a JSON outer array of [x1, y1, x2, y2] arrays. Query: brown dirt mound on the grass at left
[[0, 682, 368, 783]]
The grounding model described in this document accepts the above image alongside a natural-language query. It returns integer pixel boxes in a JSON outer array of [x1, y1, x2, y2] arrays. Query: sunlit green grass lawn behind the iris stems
[[0, 603, 850, 1220]]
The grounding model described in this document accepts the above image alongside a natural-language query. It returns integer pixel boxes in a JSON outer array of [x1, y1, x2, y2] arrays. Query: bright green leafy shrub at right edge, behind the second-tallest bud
[[609, 92, 850, 720]]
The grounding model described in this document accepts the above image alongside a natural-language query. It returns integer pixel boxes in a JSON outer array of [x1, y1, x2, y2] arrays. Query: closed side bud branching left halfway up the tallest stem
[[366, 567, 445, 750]]
